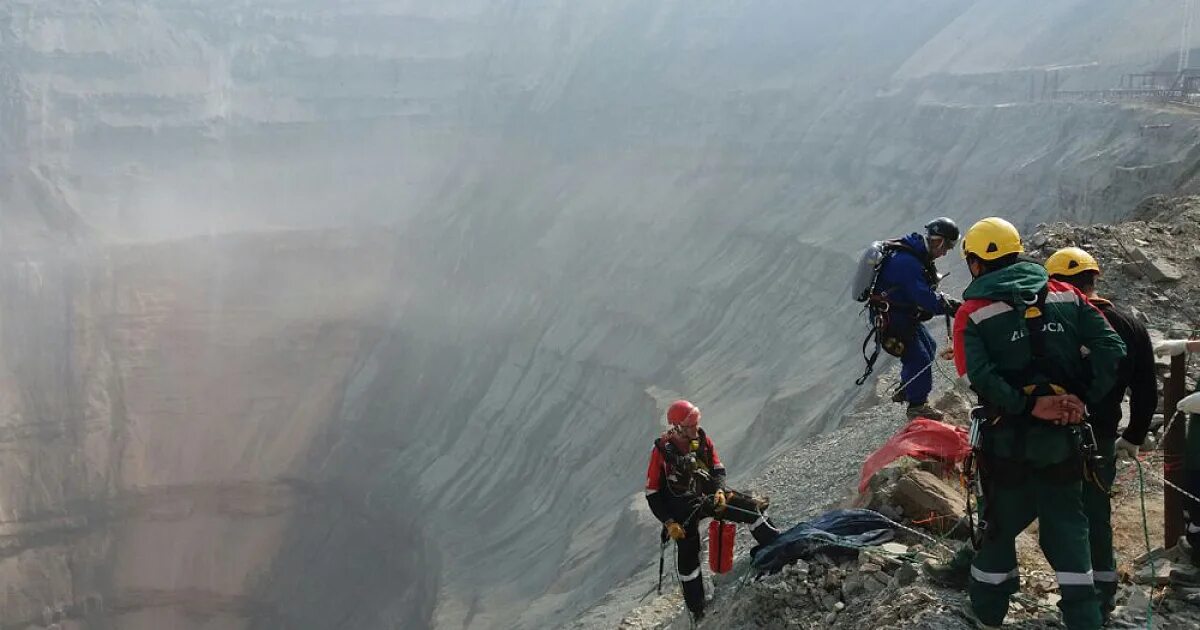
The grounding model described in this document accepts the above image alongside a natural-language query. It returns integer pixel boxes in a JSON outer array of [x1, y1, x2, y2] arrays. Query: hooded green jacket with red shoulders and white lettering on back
[[954, 260, 1126, 464]]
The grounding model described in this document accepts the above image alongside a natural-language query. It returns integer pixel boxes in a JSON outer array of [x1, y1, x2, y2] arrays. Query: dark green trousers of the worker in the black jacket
[[1084, 438, 1117, 617]]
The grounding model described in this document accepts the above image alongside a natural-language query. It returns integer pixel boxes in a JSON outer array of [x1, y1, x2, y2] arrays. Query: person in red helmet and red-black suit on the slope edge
[[646, 401, 779, 619]]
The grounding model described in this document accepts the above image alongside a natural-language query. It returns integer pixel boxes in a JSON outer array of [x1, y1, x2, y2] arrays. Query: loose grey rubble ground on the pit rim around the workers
[[609, 197, 1200, 630]]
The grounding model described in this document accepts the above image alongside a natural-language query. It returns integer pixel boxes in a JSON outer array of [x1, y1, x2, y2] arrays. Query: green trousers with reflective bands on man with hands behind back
[[967, 474, 1100, 630]]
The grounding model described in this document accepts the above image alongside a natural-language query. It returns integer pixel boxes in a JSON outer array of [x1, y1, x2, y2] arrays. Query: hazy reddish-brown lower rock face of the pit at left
[[0, 232, 437, 629]]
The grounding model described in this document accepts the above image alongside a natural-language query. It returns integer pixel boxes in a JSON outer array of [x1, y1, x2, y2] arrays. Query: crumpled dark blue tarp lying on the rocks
[[754, 510, 895, 572]]
